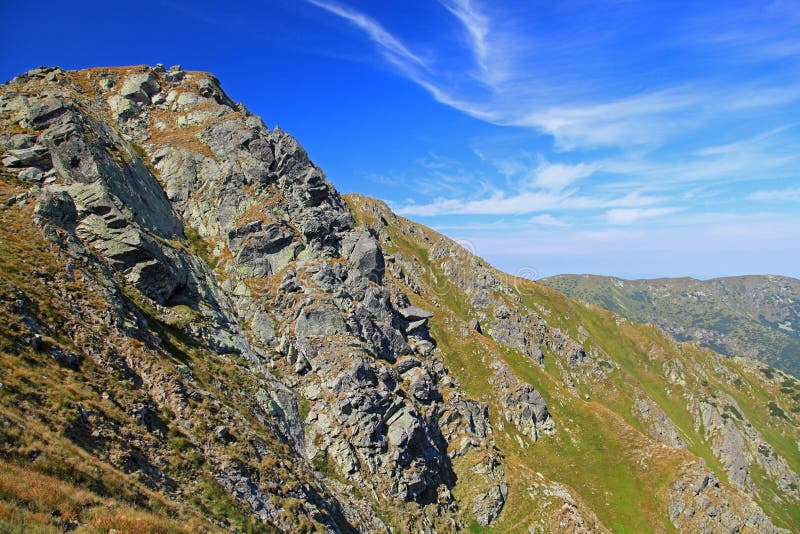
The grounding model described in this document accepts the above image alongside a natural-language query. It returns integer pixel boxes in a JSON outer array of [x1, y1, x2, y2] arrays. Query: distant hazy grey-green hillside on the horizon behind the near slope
[[540, 274, 800, 376]]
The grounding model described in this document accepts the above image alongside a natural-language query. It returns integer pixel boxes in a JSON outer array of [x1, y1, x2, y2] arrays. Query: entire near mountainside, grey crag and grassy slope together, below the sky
[[0, 67, 800, 532]]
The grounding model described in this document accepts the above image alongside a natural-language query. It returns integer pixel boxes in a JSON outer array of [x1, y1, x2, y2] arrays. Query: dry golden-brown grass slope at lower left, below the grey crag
[[0, 168, 298, 533]]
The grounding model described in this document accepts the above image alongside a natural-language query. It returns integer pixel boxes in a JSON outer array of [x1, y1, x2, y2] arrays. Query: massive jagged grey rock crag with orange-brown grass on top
[[0, 67, 520, 528]]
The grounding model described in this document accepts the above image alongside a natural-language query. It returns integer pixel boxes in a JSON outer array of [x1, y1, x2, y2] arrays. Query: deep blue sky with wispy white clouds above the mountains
[[0, 0, 800, 278]]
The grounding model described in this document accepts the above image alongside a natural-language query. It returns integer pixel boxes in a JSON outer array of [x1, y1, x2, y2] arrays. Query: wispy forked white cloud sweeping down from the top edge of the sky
[[308, 0, 800, 150]]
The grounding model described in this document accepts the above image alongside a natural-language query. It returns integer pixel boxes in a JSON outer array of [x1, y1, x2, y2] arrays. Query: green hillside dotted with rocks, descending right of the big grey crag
[[348, 197, 800, 531]]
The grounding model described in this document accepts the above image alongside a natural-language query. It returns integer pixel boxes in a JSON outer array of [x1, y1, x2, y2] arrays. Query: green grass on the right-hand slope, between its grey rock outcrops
[[347, 195, 800, 532]]
